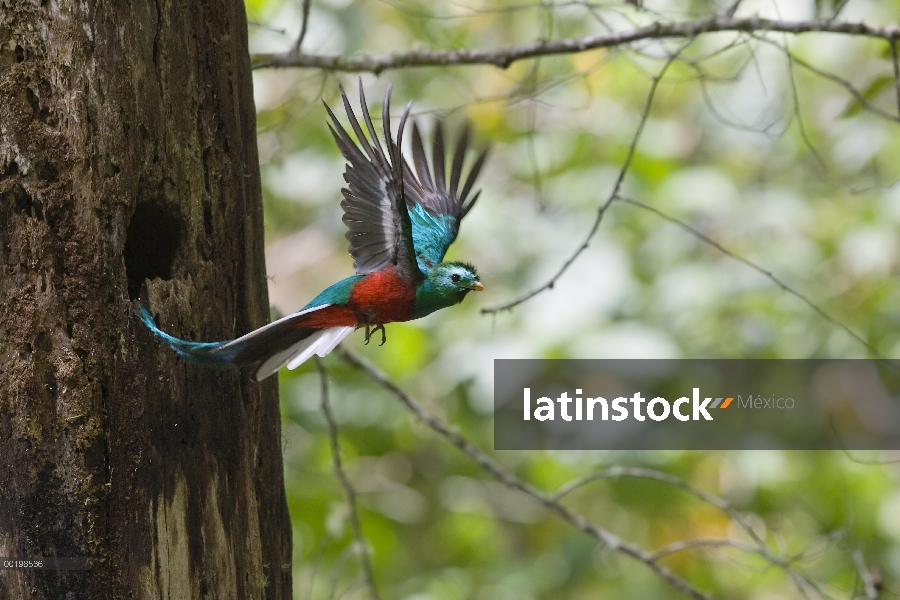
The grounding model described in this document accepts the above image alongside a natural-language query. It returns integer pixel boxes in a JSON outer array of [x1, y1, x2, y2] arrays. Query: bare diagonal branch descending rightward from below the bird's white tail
[[336, 346, 712, 600]]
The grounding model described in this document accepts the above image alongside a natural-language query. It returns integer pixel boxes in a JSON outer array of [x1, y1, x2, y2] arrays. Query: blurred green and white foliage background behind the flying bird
[[246, 0, 900, 600]]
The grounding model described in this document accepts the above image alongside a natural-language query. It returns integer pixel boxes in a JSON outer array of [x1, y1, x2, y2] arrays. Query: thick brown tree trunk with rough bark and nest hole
[[0, 0, 290, 600]]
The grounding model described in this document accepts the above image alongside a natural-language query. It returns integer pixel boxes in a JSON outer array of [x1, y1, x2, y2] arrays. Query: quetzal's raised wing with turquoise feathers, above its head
[[403, 122, 488, 271]]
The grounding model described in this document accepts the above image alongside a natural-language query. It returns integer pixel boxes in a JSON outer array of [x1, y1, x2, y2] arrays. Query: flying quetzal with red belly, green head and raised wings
[[138, 85, 487, 379]]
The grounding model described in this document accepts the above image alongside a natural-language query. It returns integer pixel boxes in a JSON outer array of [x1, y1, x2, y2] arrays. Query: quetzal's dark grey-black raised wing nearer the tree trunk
[[325, 84, 422, 284]]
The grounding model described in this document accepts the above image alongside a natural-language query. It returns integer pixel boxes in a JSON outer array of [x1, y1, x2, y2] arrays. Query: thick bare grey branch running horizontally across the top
[[253, 14, 900, 74]]
